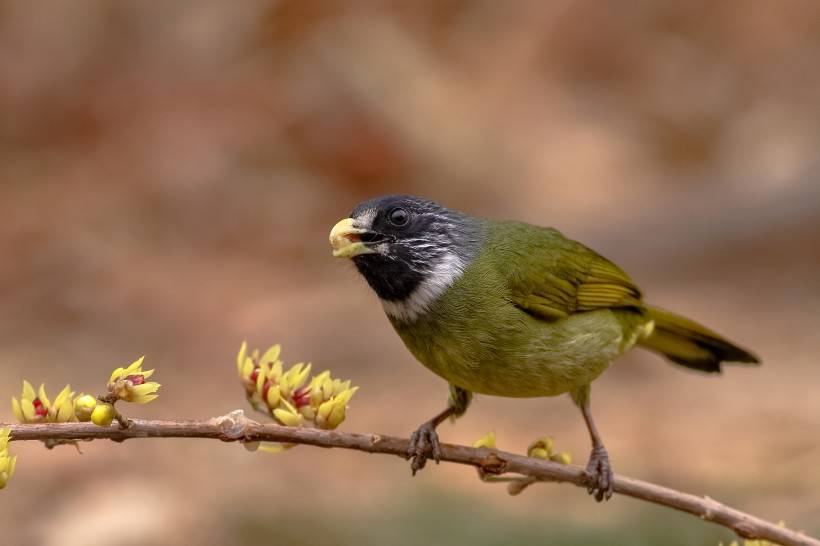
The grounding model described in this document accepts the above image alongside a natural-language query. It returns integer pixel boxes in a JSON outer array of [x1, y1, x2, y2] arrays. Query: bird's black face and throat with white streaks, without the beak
[[350, 195, 478, 301]]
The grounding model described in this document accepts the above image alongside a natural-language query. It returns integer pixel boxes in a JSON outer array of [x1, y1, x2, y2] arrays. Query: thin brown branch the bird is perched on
[[0, 410, 820, 546]]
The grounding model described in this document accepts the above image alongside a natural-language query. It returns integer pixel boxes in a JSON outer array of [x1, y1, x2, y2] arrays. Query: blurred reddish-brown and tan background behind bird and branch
[[0, 0, 820, 546]]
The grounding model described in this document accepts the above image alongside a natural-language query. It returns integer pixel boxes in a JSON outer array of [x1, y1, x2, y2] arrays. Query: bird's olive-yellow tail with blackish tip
[[639, 307, 760, 372]]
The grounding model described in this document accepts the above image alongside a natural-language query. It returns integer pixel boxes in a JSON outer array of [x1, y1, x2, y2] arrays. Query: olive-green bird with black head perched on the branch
[[330, 195, 760, 502]]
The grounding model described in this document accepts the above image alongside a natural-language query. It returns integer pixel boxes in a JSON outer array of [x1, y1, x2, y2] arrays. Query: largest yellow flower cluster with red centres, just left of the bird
[[236, 343, 358, 430]]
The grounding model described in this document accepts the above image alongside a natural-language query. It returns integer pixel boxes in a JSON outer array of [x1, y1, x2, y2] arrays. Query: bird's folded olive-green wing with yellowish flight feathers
[[495, 223, 643, 320]]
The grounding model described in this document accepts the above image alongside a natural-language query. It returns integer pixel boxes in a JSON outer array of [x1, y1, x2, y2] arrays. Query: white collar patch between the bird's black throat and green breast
[[381, 252, 466, 322]]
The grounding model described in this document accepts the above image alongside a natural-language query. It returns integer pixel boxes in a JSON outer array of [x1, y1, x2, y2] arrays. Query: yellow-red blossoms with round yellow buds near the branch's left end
[[11, 357, 160, 426]]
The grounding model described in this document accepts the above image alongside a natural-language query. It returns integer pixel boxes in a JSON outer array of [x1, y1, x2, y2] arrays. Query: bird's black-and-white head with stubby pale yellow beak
[[330, 195, 480, 320]]
